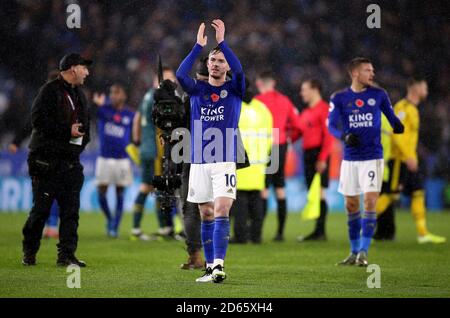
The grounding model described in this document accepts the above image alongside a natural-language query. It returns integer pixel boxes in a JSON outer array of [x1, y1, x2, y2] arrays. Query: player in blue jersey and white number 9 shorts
[[328, 58, 404, 266]]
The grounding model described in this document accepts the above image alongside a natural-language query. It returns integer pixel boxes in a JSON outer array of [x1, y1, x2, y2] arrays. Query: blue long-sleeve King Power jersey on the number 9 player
[[328, 86, 401, 161]]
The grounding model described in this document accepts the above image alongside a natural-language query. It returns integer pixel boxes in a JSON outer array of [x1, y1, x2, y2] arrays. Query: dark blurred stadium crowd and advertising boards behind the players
[[0, 0, 450, 212]]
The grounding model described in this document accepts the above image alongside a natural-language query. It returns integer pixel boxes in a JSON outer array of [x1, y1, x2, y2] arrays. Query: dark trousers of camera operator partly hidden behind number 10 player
[[180, 163, 202, 254]]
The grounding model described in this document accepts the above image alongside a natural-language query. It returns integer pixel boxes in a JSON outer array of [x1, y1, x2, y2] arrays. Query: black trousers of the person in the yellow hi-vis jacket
[[231, 190, 264, 243]]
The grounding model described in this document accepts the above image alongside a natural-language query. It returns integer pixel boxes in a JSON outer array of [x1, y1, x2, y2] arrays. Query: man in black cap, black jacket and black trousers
[[22, 53, 92, 267]]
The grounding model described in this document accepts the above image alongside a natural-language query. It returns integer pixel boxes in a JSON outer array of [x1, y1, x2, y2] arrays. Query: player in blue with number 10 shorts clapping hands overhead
[[176, 19, 245, 283]]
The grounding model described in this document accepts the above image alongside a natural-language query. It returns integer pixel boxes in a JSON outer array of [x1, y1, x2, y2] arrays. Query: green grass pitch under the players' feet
[[0, 211, 450, 298]]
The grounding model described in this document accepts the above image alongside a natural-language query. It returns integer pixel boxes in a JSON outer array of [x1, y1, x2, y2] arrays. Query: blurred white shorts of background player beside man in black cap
[[95, 157, 133, 187]]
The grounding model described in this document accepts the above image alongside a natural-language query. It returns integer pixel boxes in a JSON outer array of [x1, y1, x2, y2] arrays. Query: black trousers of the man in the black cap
[[22, 156, 84, 255]]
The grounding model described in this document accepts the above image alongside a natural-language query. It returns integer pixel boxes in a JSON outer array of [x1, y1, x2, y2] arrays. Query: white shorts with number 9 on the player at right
[[338, 159, 384, 196]]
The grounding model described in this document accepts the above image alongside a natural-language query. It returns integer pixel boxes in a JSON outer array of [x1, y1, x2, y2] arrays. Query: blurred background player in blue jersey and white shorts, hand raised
[[94, 83, 134, 238]]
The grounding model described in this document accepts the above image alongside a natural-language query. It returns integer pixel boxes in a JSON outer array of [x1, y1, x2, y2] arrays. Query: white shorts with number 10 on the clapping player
[[187, 162, 237, 203]]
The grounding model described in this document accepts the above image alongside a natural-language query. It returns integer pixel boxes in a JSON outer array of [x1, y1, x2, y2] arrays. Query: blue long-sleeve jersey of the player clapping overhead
[[176, 41, 245, 163]]
